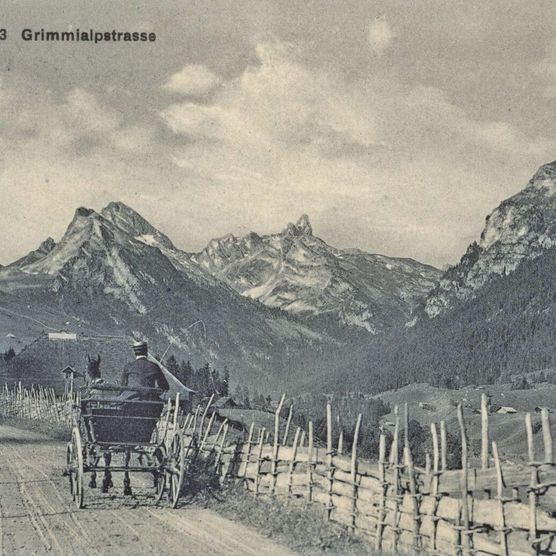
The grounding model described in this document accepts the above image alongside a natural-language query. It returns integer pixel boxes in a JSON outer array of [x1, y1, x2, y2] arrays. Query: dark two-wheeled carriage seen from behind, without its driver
[[67, 384, 192, 508]]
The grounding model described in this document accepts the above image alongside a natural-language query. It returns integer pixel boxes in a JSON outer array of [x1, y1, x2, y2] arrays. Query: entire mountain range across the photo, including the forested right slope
[[5, 162, 556, 392]]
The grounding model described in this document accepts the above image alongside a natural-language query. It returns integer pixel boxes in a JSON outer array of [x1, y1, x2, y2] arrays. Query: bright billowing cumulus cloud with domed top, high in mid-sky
[[162, 42, 375, 152]]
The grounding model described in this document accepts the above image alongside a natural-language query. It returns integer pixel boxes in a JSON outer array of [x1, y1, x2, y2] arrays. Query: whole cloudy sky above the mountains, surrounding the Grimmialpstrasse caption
[[0, 0, 556, 267]]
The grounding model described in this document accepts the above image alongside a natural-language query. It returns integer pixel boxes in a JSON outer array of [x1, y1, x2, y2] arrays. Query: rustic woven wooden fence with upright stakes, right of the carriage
[[175, 399, 556, 556]]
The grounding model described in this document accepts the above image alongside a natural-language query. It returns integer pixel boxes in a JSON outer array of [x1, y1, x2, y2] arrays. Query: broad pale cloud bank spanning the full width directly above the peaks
[[0, 41, 555, 264]]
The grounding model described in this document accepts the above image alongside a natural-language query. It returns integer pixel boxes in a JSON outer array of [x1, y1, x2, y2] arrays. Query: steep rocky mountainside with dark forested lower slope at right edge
[[328, 161, 556, 391]]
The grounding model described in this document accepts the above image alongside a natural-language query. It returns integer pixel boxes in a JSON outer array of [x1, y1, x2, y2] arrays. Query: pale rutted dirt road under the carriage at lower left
[[0, 426, 293, 556]]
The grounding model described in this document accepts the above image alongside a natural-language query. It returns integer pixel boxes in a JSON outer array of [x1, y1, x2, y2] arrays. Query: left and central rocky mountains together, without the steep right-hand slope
[[0, 202, 437, 387]]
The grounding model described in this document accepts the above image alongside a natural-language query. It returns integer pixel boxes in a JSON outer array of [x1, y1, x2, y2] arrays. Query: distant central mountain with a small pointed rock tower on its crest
[[191, 215, 440, 334]]
